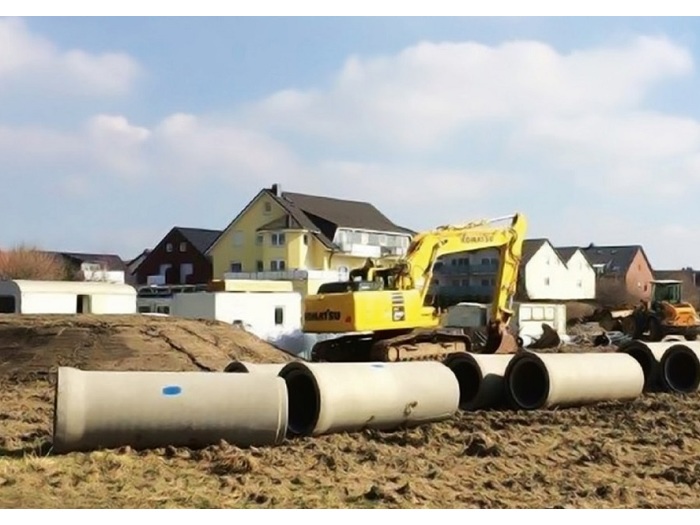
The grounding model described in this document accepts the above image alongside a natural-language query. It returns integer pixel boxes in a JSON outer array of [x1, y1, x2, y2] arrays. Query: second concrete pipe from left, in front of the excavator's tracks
[[279, 361, 459, 436]]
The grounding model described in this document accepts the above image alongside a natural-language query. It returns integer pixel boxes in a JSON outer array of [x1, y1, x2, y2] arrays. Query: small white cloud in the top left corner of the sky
[[0, 18, 141, 96]]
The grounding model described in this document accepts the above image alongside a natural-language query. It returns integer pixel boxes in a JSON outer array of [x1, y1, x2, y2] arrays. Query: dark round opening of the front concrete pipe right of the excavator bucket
[[507, 356, 549, 410]]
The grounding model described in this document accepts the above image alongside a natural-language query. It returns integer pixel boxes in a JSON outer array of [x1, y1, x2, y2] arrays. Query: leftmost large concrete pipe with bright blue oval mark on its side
[[53, 367, 287, 453]]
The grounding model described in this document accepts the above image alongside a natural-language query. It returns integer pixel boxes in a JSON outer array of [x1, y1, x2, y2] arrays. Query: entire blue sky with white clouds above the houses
[[0, 17, 700, 269]]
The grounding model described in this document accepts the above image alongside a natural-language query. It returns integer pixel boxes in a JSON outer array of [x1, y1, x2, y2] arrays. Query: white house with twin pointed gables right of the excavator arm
[[518, 239, 596, 301]]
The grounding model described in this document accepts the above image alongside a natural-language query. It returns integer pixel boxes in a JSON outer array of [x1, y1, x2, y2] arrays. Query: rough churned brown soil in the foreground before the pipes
[[0, 380, 700, 508]]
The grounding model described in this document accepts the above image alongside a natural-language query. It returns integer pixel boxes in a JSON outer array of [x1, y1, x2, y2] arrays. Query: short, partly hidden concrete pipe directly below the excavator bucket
[[443, 353, 513, 410]]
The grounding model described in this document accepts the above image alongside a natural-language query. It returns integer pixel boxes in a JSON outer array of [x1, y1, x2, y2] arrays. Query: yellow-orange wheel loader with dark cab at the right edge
[[610, 279, 700, 341]]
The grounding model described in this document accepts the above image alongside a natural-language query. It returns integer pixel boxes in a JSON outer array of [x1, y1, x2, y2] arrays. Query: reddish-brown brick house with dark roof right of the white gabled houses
[[581, 243, 654, 305]]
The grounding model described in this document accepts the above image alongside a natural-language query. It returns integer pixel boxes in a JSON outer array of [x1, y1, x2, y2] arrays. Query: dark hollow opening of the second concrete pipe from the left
[[279, 363, 321, 436]]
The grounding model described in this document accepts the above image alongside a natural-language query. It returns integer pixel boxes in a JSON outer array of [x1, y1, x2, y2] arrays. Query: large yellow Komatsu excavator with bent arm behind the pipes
[[304, 213, 527, 362]]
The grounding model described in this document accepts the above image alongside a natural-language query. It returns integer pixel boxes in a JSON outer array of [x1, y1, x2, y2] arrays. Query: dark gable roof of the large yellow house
[[207, 184, 415, 251]]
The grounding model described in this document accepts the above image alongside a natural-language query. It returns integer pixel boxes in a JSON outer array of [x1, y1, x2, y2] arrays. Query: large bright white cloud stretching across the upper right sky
[[249, 37, 693, 148]]
